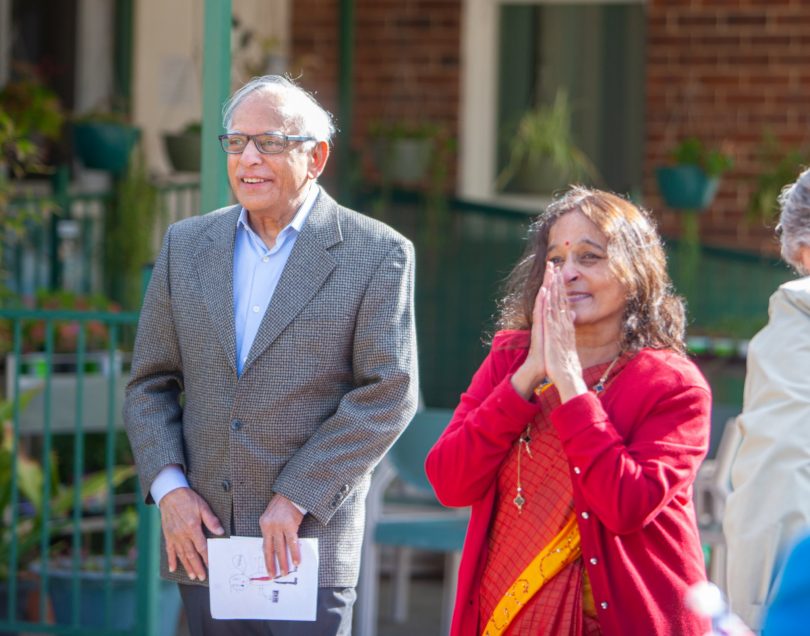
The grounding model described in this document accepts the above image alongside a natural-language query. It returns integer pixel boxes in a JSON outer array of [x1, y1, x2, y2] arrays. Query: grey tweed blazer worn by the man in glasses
[[124, 190, 418, 587]]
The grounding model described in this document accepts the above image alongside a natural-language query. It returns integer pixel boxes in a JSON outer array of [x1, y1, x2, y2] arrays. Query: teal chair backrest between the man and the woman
[[388, 408, 453, 495]]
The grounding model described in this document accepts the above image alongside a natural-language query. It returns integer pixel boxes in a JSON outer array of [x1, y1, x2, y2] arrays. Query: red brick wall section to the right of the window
[[645, 0, 810, 254]]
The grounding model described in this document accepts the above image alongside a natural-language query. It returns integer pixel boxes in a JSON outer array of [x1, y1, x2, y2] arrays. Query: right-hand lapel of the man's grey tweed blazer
[[240, 189, 343, 373]]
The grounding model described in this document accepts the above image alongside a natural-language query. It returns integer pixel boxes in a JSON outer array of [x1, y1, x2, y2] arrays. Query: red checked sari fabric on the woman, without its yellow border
[[479, 361, 612, 636]]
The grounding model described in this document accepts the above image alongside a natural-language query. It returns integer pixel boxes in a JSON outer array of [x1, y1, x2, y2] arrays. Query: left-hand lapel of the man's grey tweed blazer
[[194, 205, 242, 373]]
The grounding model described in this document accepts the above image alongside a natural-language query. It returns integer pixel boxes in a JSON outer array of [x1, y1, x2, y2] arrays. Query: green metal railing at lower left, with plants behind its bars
[[0, 309, 169, 636]]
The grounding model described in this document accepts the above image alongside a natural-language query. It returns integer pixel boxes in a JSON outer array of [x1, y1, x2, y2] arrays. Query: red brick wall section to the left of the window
[[292, 0, 461, 189]]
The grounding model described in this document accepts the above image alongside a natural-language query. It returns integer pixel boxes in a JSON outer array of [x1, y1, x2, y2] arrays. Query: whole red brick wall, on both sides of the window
[[292, 0, 810, 254]]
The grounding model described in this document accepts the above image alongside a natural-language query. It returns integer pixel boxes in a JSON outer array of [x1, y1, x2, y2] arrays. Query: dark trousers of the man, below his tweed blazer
[[178, 584, 357, 636]]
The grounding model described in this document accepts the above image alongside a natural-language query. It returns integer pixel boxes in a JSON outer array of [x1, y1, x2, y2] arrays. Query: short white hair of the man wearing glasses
[[222, 75, 335, 143]]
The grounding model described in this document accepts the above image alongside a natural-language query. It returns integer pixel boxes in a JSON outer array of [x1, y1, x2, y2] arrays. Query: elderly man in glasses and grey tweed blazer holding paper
[[124, 76, 418, 636]]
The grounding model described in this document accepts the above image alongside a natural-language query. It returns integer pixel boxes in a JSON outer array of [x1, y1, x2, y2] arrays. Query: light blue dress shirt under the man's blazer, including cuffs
[[149, 183, 320, 506]]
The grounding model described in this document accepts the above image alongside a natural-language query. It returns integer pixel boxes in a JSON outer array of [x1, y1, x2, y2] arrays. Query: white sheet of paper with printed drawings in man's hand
[[208, 537, 318, 621]]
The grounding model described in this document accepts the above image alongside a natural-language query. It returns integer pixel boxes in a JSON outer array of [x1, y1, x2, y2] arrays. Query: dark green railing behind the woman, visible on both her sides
[[358, 193, 793, 408]]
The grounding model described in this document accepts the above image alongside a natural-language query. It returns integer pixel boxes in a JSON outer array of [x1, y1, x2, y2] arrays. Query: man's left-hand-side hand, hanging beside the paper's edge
[[160, 488, 225, 581]]
